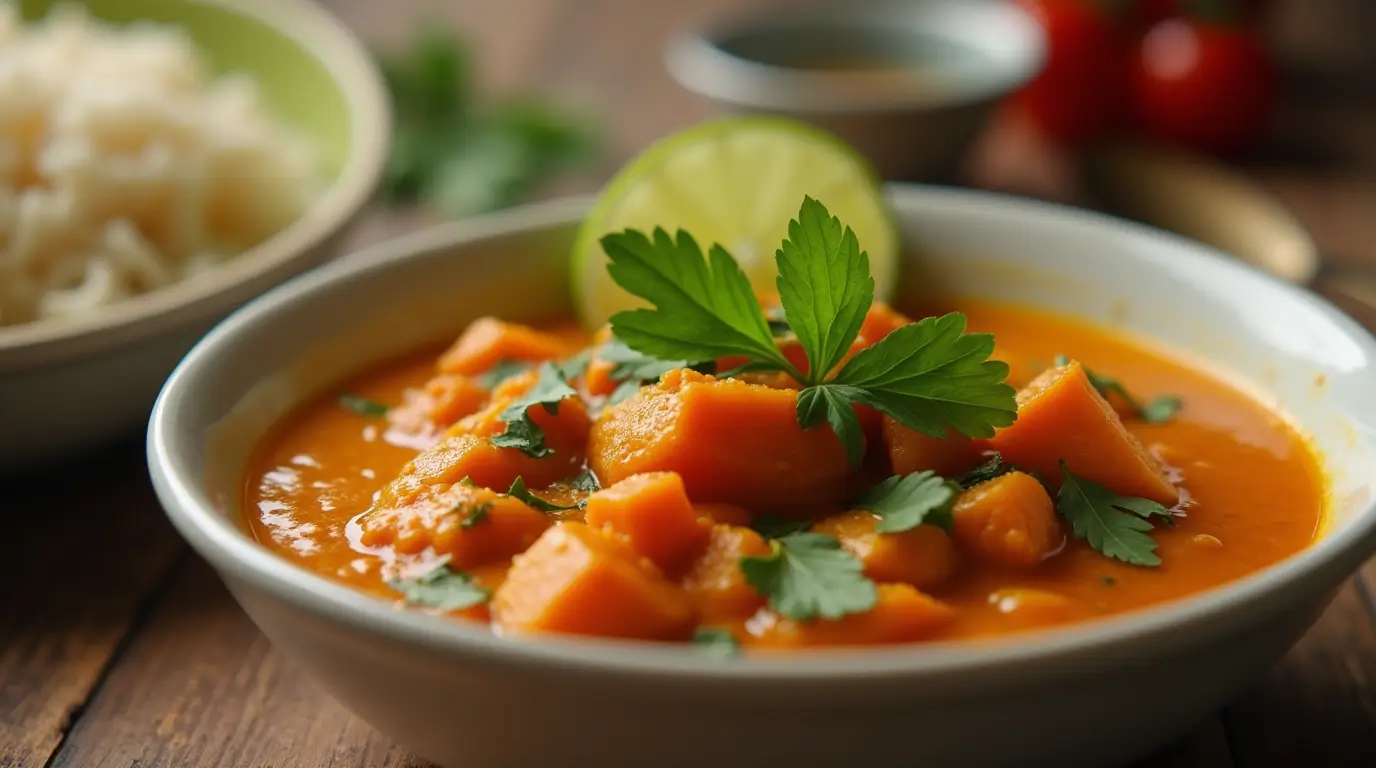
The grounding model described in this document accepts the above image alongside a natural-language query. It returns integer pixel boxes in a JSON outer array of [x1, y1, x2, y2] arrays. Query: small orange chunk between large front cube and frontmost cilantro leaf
[[680, 524, 769, 623]]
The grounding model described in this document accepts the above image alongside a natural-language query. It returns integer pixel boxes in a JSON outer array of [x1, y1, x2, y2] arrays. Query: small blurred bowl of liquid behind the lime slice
[[666, 0, 1044, 180]]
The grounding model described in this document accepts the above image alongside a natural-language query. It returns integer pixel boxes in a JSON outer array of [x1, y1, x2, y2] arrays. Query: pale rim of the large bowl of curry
[[147, 184, 1376, 684]]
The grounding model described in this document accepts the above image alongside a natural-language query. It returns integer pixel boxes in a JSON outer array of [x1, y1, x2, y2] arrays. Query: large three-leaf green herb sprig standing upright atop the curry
[[601, 197, 1017, 465]]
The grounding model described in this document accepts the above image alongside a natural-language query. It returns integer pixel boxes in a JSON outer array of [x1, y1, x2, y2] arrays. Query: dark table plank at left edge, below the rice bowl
[[0, 442, 184, 767]]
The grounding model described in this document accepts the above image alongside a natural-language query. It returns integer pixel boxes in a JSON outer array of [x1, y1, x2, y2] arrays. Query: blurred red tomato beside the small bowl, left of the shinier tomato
[[1011, 0, 1131, 145]]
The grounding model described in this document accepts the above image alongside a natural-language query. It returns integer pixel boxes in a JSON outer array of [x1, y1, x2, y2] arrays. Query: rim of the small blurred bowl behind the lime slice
[[663, 0, 1046, 114]]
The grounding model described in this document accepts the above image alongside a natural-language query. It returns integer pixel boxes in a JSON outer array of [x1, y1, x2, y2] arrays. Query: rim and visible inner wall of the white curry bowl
[[149, 187, 1376, 684]]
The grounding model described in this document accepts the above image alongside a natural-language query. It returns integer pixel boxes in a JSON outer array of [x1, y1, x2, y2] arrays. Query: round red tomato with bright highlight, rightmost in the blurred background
[[1132, 18, 1276, 154]]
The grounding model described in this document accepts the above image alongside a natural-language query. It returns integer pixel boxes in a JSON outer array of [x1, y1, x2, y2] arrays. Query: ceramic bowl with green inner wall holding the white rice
[[0, 0, 391, 473]]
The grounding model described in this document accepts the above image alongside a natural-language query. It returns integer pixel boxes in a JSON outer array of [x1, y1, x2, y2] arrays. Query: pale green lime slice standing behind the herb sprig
[[572, 117, 899, 329]]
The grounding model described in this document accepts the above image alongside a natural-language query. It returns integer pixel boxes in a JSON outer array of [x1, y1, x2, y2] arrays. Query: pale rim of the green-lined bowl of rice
[[0, 0, 392, 370]]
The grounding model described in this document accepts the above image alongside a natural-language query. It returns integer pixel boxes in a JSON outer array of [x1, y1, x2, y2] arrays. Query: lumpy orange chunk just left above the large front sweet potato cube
[[359, 484, 550, 568]]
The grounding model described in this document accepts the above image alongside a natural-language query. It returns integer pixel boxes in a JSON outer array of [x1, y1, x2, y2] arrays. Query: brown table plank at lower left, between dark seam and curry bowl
[[52, 557, 429, 768]]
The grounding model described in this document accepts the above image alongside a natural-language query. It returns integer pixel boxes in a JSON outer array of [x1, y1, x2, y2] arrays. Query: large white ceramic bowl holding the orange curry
[[149, 187, 1376, 767]]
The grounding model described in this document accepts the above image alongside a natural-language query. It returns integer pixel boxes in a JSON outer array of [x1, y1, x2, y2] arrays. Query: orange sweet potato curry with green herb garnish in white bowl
[[236, 200, 1326, 652]]
